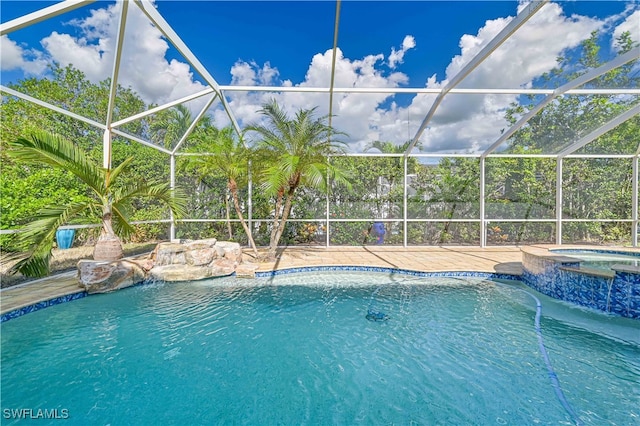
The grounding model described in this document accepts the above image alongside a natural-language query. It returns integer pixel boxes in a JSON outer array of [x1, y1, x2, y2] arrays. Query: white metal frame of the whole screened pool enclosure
[[0, 0, 640, 247]]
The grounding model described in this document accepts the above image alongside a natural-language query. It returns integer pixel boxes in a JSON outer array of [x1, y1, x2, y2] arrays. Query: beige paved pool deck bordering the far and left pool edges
[[0, 245, 637, 314]]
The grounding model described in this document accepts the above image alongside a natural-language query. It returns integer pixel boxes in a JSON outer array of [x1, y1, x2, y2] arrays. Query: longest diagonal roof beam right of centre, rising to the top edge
[[404, 0, 549, 155]]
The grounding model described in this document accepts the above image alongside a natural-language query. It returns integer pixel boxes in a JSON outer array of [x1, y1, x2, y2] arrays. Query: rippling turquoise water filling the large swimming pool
[[1, 272, 640, 425]]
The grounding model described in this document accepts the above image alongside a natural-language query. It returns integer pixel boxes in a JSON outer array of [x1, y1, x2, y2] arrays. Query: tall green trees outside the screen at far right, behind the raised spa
[[500, 32, 640, 242]]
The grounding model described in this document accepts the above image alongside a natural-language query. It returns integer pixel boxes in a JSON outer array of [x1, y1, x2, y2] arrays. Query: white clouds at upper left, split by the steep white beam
[[2, 2, 209, 110]]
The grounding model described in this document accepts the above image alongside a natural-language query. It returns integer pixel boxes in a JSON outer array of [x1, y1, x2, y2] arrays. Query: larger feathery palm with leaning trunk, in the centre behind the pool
[[246, 100, 350, 259]]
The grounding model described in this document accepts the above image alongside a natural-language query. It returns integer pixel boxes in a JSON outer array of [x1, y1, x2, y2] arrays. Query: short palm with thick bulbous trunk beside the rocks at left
[[7, 131, 185, 277]]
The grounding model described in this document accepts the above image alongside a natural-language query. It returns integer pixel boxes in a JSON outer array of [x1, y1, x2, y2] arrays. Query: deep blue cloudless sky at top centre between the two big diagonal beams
[[158, 1, 517, 85]]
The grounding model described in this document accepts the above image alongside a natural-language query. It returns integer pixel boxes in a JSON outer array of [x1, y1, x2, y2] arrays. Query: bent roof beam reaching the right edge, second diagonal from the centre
[[482, 47, 640, 157]]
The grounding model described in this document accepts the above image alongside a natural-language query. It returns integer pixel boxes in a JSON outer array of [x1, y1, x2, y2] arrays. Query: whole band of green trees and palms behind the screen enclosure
[[0, 29, 640, 272]]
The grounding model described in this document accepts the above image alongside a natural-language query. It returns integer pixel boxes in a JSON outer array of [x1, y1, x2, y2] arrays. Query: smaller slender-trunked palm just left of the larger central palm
[[181, 127, 258, 258]]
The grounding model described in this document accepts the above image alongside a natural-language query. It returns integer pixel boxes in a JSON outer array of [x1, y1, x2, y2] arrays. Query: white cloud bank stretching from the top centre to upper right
[[234, 4, 602, 152]]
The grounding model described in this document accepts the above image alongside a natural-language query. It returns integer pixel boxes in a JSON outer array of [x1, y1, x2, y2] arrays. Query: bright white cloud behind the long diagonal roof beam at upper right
[[370, 3, 602, 152]]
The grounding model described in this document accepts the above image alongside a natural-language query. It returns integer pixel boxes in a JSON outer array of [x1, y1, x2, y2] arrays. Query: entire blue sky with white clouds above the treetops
[[0, 0, 640, 153]]
